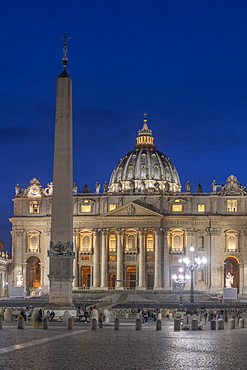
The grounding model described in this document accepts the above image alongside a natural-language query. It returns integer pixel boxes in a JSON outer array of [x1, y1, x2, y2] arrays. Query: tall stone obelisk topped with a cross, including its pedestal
[[48, 33, 74, 308]]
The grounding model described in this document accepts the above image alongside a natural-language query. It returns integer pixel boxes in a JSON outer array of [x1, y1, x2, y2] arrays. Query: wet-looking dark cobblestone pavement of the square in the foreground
[[0, 319, 247, 370]]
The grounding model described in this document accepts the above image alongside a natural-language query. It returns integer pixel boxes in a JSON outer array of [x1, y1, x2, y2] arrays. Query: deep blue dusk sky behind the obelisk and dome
[[0, 0, 247, 251]]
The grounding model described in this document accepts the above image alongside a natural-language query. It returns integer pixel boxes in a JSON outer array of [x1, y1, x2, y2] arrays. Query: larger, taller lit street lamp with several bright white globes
[[178, 245, 207, 311]]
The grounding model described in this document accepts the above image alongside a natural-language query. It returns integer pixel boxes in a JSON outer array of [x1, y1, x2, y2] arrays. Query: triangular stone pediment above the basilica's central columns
[[101, 202, 163, 219]]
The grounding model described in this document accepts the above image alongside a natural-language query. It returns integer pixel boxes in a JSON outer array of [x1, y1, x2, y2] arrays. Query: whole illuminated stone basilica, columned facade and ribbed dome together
[[10, 117, 247, 294]]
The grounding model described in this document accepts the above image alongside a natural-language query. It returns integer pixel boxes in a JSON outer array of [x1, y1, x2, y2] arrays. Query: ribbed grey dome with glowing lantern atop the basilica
[[109, 117, 181, 193]]
